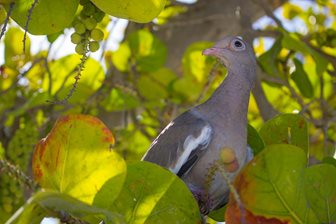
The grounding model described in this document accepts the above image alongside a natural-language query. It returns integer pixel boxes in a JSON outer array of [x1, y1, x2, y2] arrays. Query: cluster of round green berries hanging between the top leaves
[[71, 0, 105, 55]]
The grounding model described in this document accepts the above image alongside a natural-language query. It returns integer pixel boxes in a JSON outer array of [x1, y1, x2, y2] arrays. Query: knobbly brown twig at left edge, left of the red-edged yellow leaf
[[0, 159, 37, 190]]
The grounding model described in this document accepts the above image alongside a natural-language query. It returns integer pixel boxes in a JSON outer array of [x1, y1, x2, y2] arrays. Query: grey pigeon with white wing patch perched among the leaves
[[142, 36, 256, 215]]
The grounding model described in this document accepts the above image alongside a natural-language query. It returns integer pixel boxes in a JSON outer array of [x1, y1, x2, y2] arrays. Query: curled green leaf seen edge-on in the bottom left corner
[[6, 191, 123, 224]]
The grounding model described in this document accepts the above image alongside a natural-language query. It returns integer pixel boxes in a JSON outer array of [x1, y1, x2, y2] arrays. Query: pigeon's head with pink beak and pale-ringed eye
[[203, 36, 256, 83]]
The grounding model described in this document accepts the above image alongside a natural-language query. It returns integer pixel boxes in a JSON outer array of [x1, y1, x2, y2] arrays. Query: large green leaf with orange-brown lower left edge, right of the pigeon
[[226, 144, 318, 224]]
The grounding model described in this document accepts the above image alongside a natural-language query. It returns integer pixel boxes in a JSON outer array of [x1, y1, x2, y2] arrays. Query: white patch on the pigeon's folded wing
[[169, 125, 212, 174]]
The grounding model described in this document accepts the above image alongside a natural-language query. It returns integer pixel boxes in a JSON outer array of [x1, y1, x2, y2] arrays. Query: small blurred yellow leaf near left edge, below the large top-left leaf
[[5, 27, 30, 69]]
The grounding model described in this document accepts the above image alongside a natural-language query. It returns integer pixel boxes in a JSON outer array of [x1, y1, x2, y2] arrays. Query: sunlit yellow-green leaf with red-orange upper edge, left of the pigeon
[[33, 115, 126, 203]]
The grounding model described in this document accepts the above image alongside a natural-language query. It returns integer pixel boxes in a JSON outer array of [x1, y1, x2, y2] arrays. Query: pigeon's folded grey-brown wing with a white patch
[[142, 110, 213, 177]]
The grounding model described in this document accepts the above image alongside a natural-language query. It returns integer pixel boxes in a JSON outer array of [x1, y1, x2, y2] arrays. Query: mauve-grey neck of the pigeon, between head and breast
[[200, 70, 254, 125]]
